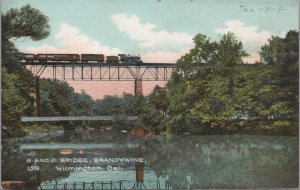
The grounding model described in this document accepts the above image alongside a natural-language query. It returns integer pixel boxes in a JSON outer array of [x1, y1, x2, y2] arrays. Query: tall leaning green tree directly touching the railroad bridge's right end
[[167, 34, 217, 132]]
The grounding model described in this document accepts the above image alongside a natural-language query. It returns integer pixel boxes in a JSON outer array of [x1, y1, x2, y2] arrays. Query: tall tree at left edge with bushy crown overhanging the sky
[[1, 5, 50, 137]]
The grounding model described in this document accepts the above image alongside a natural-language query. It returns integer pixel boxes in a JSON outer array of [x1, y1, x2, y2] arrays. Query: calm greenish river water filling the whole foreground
[[2, 131, 299, 189]]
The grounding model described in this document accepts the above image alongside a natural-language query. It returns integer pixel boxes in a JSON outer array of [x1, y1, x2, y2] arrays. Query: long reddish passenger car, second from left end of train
[[36, 54, 80, 62]]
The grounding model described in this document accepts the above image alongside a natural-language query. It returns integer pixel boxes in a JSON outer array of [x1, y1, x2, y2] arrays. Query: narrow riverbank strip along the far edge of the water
[[2, 123, 299, 142]]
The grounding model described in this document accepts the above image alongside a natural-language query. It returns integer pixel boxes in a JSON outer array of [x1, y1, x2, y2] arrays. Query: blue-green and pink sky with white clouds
[[1, 0, 299, 99]]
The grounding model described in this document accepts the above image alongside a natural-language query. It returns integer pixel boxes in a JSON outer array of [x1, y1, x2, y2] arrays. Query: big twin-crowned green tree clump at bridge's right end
[[167, 33, 247, 134]]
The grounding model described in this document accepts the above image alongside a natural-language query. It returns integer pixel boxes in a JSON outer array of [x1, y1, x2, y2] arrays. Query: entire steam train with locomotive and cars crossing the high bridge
[[23, 53, 143, 64]]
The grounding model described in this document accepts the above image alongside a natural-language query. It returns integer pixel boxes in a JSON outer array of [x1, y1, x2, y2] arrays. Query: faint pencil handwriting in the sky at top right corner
[[239, 3, 284, 13]]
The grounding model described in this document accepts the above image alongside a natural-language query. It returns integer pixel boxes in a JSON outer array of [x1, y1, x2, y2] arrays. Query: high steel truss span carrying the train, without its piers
[[21, 61, 175, 81]]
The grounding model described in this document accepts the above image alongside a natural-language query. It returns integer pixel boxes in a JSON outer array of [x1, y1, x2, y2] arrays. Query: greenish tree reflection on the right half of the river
[[140, 136, 298, 188]]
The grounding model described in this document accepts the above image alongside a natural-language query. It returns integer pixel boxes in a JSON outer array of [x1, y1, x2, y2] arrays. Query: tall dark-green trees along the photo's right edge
[[253, 30, 299, 134]]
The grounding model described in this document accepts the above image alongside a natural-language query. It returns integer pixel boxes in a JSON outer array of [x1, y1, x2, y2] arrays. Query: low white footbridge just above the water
[[21, 116, 138, 122]]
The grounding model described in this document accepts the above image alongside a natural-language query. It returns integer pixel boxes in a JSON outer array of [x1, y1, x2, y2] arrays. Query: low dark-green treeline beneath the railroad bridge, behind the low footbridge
[[40, 79, 144, 130]]
